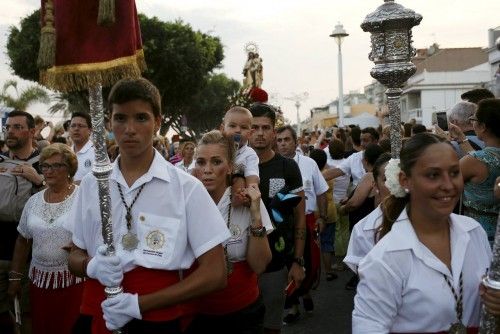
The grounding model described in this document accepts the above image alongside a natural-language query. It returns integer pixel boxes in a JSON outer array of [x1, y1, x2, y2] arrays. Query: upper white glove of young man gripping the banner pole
[[87, 245, 123, 287]]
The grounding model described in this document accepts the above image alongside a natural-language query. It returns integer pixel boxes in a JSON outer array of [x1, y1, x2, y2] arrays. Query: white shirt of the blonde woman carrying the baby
[[217, 188, 274, 262]]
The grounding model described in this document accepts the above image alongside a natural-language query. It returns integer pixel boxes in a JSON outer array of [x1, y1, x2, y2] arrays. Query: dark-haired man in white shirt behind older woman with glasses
[[69, 112, 95, 183]]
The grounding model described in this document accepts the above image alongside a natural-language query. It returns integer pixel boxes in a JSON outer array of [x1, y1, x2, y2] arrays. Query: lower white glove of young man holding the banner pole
[[101, 293, 142, 331]]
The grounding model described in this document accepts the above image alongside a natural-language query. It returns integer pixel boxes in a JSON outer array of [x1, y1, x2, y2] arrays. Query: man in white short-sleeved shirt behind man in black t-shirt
[[276, 125, 328, 323]]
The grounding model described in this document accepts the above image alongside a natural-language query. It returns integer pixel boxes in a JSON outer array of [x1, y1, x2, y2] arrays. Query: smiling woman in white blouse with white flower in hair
[[352, 133, 500, 333]]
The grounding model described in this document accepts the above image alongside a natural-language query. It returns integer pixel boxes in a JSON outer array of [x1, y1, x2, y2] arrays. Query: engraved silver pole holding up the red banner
[[89, 84, 123, 334]]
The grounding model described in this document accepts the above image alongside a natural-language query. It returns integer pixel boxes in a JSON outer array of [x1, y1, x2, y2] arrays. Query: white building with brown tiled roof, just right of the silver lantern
[[401, 45, 492, 126]]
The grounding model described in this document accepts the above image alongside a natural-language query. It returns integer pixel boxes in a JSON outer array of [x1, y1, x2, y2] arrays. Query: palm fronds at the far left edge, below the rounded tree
[[0, 79, 50, 110]]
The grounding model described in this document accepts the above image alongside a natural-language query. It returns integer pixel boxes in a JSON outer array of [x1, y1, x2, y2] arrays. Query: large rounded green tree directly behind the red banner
[[7, 11, 239, 133]]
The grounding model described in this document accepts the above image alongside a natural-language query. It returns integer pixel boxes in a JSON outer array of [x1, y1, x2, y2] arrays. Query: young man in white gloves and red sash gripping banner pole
[[66, 78, 231, 333]]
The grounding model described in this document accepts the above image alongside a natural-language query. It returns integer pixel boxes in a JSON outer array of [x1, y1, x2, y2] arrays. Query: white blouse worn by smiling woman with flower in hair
[[352, 210, 491, 334]]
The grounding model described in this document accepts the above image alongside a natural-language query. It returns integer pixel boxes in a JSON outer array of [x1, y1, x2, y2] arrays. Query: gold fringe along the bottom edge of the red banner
[[40, 52, 146, 93]]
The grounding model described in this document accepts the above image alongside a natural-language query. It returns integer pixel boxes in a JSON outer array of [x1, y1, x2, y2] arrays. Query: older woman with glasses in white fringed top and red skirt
[[8, 143, 83, 334]]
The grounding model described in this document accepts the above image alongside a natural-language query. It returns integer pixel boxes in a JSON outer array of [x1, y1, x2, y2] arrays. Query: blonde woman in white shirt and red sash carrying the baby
[[190, 130, 273, 334]]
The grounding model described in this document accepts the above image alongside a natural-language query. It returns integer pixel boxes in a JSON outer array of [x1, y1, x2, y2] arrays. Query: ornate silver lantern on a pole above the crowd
[[361, 0, 422, 158]]
